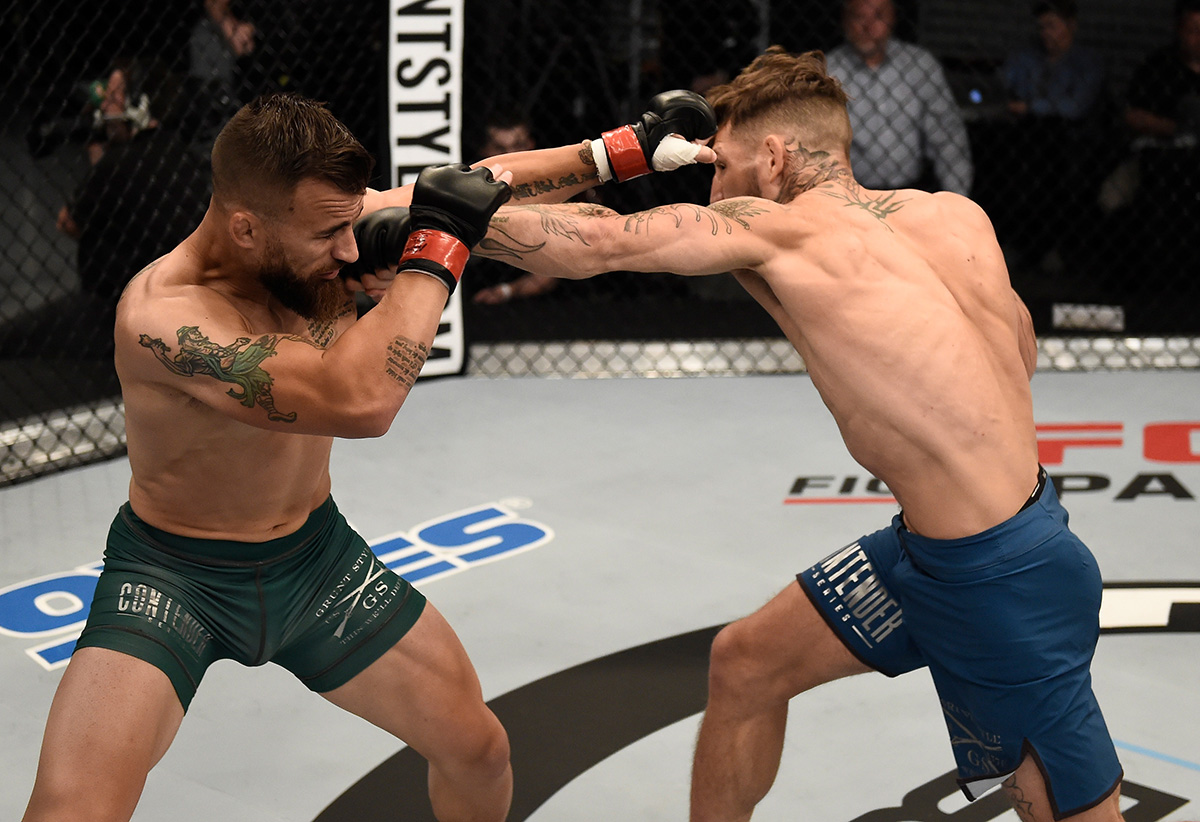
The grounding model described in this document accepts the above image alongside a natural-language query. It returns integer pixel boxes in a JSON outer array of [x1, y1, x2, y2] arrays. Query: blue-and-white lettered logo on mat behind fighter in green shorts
[[0, 503, 554, 671]]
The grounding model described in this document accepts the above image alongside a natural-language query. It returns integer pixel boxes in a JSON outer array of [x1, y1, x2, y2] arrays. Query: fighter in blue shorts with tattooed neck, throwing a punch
[[465, 46, 1121, 822]]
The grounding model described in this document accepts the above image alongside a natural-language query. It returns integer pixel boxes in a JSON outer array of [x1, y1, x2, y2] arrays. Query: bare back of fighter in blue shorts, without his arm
[[724, 184, 1037, 539]]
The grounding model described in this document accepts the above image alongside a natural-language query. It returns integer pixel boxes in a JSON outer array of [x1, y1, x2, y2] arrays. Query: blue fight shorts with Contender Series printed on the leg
[[797, 470, 1122, 820]]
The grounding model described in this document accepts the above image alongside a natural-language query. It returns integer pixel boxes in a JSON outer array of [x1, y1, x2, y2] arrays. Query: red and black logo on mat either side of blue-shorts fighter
[[784, 422, 1200, 505]]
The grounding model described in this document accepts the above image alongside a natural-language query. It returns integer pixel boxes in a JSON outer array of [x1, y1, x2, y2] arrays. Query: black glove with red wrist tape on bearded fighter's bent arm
[[400, 163, 512, 293]]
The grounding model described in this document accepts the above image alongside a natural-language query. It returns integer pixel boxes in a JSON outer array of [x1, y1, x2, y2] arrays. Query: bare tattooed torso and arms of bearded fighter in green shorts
[[115, 140, 595, 542]]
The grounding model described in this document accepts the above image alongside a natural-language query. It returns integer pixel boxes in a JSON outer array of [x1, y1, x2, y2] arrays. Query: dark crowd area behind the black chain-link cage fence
[[0, 0, 1200, 429]]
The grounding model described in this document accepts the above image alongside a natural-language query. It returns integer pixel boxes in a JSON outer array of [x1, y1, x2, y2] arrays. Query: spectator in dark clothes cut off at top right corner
[[1126, 0, 1200, 138]]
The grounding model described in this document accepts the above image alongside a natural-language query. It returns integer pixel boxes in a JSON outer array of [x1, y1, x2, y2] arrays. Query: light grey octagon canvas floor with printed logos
[[0, 371, 1200, 822]]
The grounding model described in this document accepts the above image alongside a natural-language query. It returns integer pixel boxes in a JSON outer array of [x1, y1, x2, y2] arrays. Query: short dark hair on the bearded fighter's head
[[212, 92, 374, 210]]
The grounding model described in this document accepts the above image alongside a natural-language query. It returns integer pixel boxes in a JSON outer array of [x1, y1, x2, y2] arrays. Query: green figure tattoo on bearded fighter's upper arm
[[138, 325, 297, 422]]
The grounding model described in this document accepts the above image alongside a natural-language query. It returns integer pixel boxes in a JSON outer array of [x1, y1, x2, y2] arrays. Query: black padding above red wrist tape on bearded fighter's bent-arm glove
[[410, 163, 512, 247]]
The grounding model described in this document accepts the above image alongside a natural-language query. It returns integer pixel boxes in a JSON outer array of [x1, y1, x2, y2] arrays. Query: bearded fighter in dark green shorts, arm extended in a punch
[[18, 94, 713, 821]]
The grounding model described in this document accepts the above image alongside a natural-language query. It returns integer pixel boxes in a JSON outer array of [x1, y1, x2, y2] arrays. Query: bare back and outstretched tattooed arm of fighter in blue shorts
[[492, 180, 1037, 539]]
